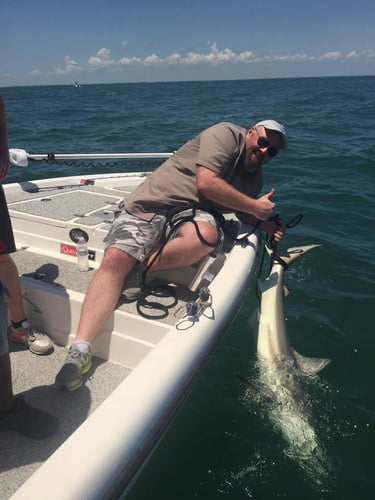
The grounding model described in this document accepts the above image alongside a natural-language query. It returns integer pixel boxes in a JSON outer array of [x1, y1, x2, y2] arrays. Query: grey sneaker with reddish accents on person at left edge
[[8, 320, 53, 354]]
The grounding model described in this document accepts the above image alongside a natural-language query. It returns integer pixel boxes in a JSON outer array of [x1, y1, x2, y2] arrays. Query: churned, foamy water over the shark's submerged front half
[[246, 356, 335, 492]]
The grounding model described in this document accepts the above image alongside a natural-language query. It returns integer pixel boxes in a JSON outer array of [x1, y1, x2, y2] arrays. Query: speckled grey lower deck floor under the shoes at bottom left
[[0, 344, 131, 500]]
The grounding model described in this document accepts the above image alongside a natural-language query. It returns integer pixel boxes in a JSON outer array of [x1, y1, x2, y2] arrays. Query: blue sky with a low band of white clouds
[[0, 0, 375, 88]]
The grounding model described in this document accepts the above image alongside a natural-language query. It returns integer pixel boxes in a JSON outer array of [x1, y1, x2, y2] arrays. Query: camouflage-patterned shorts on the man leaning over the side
[[103, 209, 223, 262]]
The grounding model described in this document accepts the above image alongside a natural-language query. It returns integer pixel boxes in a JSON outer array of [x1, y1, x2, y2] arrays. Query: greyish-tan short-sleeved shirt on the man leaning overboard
[[124, 122, 263, 220]]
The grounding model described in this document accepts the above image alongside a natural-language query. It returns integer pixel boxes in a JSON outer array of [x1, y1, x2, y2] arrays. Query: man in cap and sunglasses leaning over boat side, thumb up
[[55, 120, 287, 390]]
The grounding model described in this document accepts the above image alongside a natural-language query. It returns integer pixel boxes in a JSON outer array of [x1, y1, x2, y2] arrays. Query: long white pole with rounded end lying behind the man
[[9, 148, 173, 167]]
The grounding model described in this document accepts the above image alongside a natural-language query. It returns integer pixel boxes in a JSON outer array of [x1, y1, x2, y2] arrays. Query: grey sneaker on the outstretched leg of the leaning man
[[55, 344, 91, 391]]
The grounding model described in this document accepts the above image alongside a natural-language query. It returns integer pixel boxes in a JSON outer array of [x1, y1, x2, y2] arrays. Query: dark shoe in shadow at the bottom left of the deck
[[0, 395, 59, 439]]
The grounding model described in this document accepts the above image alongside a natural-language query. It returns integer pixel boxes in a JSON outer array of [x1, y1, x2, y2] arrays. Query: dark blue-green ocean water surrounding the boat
[[1, 77, 375, 500]]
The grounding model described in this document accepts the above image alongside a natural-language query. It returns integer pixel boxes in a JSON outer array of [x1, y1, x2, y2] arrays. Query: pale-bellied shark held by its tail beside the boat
[[252, 245, 333, 491]]
